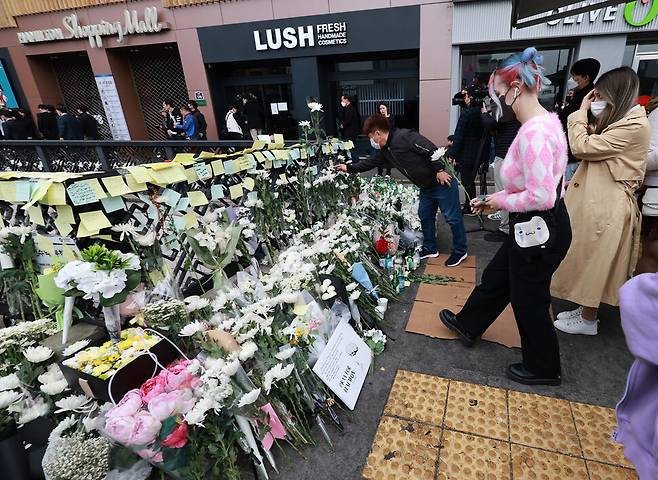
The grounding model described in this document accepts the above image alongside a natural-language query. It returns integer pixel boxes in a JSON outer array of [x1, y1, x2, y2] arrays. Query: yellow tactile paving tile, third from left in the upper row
[[509, 391, 582, 454]]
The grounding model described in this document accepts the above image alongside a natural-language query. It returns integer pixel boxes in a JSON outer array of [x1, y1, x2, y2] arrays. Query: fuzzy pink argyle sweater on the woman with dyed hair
[[494, 113, 567, 212]]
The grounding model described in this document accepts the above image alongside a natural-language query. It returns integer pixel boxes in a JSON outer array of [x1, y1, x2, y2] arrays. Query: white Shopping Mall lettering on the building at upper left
[[17, 7, 169, 48]]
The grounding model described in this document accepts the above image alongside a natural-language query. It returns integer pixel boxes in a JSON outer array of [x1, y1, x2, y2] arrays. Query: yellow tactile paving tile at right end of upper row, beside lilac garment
[[571, 402, 633, 467]]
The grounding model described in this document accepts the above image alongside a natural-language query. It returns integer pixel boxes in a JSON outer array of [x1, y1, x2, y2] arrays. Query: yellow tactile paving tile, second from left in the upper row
[[445, 380, 509, 440]]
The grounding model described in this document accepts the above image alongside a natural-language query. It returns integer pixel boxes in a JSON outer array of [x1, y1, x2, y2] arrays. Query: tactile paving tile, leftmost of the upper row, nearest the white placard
[[384, 370, 448, 425]]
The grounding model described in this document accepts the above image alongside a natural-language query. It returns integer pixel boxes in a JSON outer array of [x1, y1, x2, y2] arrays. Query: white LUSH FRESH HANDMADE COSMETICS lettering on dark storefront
[[254, 22, 347, 51]]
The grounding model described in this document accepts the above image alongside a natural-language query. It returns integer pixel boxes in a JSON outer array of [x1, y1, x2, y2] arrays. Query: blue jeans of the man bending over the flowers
[[418, 179, 467, 255]]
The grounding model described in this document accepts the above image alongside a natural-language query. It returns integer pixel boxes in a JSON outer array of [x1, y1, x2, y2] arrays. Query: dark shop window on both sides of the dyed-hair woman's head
[[461, 48, 571, 110]]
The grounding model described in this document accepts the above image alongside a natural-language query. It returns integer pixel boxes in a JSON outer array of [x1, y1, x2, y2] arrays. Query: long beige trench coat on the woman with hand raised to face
[[551, 106, 651, 308]]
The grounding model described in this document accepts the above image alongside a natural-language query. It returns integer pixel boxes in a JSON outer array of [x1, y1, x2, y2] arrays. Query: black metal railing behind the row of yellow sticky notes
[[0, 140, 299, 172]]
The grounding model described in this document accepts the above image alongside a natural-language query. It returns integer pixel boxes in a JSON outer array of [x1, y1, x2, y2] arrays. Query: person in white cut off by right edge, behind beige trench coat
[[635, 97, 658, 275]]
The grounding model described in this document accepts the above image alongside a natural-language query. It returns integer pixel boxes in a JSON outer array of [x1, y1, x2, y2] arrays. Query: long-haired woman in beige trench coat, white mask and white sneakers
[[551, 67, 651, 335]]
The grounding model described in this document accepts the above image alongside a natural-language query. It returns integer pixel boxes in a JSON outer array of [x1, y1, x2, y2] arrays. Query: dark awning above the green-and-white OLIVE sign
[[512, 0, 626, 28]]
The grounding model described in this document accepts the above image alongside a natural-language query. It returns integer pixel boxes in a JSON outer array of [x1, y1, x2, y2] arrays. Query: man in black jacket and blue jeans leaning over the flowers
[[336, 115, 468, 267]]
